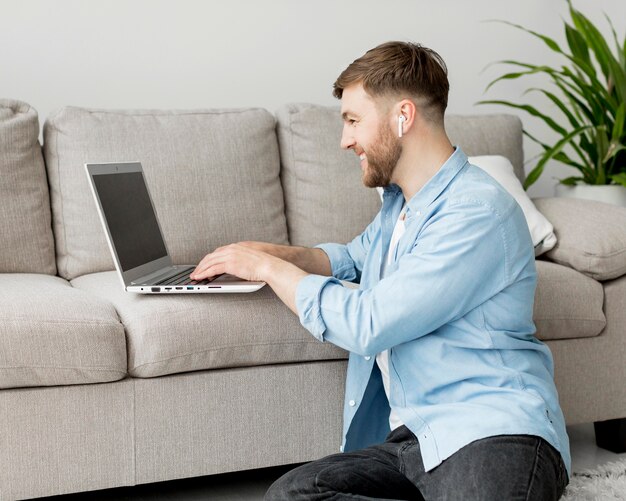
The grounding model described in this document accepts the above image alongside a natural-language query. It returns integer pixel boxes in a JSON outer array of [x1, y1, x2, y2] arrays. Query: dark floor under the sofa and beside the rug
[[40, 424, 626, 501]]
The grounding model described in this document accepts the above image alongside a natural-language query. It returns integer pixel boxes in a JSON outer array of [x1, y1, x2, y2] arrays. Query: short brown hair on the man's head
[[333, 42, 450, 123]]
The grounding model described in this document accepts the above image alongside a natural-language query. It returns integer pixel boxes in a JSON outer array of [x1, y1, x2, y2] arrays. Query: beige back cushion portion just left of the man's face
[[276, 104, 380, 246]]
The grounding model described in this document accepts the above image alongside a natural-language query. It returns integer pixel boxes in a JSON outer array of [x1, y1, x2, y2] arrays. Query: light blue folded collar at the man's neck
[[383, 146, 467, 218]]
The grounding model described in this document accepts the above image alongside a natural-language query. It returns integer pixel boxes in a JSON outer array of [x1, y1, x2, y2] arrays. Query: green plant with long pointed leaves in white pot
[[479, 0, 626, 206]]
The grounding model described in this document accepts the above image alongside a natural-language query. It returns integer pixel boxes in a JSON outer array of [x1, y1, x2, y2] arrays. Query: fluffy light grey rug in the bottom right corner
[[561, 459, 626, 501]]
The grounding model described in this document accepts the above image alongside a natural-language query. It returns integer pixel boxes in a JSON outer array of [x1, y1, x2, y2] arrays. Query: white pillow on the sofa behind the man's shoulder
[[377, 155, 556, 256]]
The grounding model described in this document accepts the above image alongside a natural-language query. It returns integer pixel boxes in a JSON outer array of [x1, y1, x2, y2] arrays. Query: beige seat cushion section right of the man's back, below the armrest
[[533, 260, 606, 340]]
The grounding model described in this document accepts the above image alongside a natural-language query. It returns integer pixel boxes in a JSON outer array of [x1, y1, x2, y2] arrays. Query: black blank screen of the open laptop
[[93, 172, 167, 271]]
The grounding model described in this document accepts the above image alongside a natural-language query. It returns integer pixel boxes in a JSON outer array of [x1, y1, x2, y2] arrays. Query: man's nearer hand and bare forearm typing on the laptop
[[190, 243, 308, 315]]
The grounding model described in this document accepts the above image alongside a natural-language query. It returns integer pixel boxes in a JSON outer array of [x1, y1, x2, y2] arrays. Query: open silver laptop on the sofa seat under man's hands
[[85, 162, 265, 294]]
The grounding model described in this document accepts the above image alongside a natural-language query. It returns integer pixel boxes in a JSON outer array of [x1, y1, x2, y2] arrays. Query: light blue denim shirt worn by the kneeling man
[[296, 147, 571, 472]]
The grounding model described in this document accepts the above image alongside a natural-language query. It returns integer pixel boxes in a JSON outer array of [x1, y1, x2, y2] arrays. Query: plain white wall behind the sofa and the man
[[0, 0, 626, 196]]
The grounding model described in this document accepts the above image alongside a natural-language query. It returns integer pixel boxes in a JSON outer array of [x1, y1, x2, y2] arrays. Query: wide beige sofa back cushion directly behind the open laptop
[[44, 107, 287, 279]]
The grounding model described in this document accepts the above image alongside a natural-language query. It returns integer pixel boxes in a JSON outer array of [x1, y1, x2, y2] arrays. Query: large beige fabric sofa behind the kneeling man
[[0, 99, 626, 500]]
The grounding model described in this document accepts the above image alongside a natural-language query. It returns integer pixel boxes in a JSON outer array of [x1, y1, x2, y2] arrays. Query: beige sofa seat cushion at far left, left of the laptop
[[0, 273, 126, 388]]
